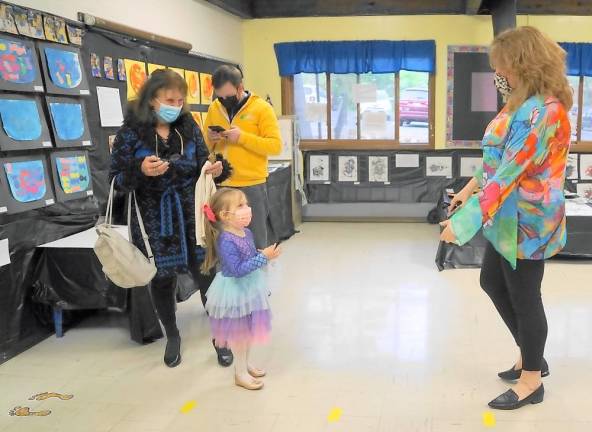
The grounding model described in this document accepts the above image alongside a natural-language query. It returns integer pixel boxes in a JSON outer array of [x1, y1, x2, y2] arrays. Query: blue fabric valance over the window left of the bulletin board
[[274, 40, 436, 76]]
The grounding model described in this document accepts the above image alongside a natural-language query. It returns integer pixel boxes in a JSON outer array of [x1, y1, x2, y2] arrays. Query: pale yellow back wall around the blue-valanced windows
[[243, 15, 592, 148]]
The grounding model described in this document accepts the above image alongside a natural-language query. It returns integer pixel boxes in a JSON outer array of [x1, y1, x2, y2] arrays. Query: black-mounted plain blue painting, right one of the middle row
[[45, 96, 92, 147]]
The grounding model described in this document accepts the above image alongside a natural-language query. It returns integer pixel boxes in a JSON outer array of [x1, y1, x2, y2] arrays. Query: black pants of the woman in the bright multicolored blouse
[[481, 244, 547, 371]]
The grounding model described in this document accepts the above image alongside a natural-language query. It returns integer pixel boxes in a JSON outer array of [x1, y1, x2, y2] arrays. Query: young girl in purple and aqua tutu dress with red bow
[[202, 188, 280, 390]]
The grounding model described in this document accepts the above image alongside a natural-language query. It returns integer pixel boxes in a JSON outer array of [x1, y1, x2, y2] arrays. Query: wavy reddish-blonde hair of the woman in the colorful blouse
[[489, 26, 573, 111]]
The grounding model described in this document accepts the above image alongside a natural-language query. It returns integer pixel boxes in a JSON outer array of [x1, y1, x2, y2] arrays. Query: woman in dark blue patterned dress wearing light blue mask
[[110, 69, 232, 367]]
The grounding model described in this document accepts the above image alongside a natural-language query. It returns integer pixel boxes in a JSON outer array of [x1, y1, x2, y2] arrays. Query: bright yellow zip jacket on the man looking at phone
[[204, 93, 282, 187]]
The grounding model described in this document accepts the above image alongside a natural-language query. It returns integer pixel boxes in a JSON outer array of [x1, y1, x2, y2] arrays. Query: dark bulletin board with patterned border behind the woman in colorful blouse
[[446, 45, 501, 147]]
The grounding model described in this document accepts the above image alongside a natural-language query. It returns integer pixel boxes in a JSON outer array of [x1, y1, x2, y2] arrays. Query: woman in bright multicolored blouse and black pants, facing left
[[441, 27, 572, 409]]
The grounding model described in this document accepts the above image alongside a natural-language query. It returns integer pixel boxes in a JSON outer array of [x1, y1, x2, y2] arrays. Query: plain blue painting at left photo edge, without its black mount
[[0, 99, 41, 141]]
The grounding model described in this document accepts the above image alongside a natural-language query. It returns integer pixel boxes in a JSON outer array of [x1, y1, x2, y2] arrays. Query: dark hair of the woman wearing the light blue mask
[[124, 69, 190, 137]]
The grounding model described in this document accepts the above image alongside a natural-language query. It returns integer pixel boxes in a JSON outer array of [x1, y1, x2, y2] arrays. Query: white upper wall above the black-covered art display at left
[[12, 0, 243, 63]]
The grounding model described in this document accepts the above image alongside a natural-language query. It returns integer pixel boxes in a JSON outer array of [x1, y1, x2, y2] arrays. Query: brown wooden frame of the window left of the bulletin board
[[281, 72, 436, 151]]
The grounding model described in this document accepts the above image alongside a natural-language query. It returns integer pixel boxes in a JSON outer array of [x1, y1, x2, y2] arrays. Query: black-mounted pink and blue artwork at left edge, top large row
[[0, 35, 44, 92]]
